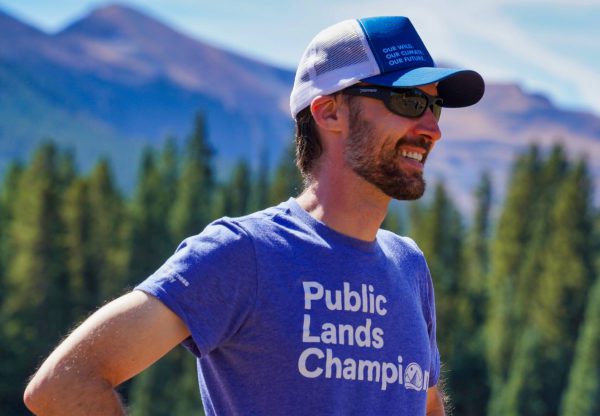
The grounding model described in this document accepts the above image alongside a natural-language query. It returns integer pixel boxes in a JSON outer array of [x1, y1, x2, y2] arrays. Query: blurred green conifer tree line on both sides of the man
[[0, 115, 600, 416]]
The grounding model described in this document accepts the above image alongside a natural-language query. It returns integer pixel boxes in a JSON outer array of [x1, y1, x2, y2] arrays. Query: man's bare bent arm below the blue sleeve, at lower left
[[24, 291, 189, 416]]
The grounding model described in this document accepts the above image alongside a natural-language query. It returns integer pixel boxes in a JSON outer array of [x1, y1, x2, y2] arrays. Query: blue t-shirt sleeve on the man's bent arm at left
[[135, 219, 256, 356]]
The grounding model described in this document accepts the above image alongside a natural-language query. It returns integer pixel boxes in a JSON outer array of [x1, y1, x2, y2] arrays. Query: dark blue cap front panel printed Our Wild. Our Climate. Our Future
[[358, 16, 434, 73]]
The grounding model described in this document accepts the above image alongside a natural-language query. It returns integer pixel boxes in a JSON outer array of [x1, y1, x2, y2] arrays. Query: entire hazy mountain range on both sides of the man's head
[[0, 5, 600, 209]]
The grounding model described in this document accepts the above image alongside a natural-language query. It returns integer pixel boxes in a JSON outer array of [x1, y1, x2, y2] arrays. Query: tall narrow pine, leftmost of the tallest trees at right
[[485, 146, 541, 415]]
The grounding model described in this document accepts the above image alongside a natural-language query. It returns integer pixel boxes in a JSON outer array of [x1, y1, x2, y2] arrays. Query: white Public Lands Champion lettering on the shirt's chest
[[298, 281, 429, 392]]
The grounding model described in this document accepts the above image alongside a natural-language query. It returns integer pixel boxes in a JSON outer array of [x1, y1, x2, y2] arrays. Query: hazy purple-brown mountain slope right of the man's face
[[428, 84, 600, 208]]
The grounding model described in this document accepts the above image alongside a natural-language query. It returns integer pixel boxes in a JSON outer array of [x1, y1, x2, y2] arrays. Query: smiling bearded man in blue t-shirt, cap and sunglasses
[[25, 17, 484, 415]]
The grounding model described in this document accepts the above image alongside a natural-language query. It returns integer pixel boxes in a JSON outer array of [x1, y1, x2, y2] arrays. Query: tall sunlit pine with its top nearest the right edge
[[511, 158, 594, 415]]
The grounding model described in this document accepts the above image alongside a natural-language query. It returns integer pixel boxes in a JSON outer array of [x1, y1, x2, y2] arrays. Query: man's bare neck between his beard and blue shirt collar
[[296, 167, 391, 241]]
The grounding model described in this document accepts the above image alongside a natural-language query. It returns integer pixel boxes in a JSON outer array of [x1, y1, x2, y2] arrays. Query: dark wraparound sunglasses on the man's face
[[342, 85, 444, 120]]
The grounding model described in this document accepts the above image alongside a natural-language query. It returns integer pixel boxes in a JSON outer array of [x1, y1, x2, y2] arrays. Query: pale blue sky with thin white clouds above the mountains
[[0, 0, 600, 115]]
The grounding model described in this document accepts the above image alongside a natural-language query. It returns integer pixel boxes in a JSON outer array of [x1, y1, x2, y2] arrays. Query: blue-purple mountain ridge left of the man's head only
[[0, 6, 293, 178]]
